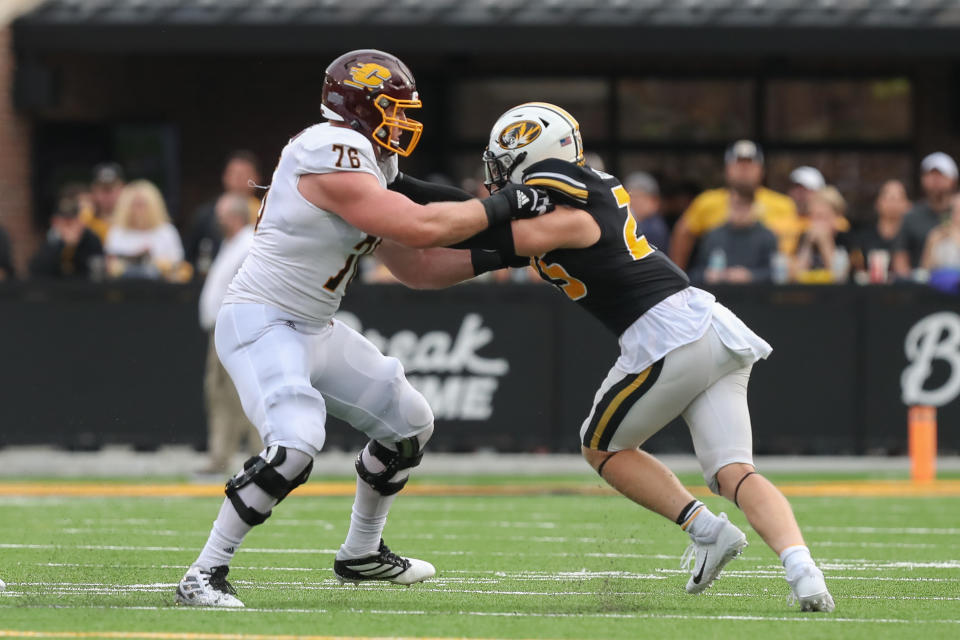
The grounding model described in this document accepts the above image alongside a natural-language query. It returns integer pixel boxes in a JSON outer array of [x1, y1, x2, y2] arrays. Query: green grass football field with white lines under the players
[[0, 474, 960, 640]]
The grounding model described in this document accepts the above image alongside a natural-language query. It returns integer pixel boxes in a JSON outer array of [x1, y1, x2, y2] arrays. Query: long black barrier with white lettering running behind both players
[[0, 282, 960, 454]]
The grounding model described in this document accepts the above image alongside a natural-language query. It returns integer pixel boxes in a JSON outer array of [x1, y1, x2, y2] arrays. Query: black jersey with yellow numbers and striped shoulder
[[523, 159, 690, 335]]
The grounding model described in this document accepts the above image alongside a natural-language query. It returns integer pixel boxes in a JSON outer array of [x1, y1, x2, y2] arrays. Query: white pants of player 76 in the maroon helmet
[[214, 304, 433, 455]]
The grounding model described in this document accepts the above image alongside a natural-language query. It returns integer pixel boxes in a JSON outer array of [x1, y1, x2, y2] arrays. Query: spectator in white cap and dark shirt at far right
[[893, 151, 957, 278]]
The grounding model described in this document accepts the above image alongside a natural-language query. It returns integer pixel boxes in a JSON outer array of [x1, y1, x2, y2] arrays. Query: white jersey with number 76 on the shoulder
[[224, 123, 387, 323]]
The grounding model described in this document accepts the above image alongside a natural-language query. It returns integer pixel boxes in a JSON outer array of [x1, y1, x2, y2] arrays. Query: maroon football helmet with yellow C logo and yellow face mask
[[323, 49, 423, 156]]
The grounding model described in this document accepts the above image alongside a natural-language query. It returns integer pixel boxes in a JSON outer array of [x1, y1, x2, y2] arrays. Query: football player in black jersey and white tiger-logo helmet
[[383, 102, 834, 611]]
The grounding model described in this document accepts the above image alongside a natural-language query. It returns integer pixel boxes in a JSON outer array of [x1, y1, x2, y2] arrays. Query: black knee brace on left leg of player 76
[[226, 445, 313, 526]]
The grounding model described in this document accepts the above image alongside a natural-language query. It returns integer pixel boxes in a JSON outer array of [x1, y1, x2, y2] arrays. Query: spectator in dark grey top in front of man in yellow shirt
[[690, 186, 777, 284]]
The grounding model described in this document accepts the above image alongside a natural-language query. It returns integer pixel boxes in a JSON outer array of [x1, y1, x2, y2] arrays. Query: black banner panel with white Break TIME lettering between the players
[[336, 286, 557, 450]]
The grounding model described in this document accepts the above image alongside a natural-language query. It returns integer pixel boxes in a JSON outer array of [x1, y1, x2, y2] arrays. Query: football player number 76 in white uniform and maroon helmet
[[176, 50, 551, 607]]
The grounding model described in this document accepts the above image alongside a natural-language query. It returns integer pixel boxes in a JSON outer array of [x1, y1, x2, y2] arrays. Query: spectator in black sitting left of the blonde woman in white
[[30, 198, 103, 278]]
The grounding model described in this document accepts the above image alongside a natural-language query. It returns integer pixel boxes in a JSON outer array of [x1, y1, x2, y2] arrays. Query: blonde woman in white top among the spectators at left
[[104, 180, 184, 280]]
